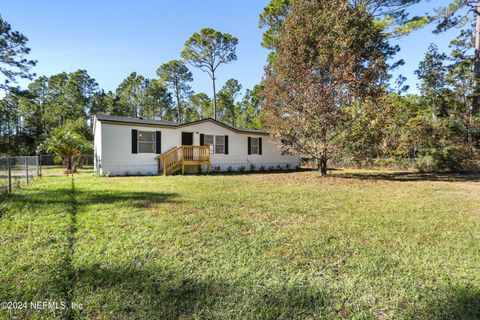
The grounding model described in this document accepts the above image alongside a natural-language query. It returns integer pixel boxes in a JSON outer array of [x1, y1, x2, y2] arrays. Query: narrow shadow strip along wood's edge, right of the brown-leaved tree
[[330, 171, 480, 182]]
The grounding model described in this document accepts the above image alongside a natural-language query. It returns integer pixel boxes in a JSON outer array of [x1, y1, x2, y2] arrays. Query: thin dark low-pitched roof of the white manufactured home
[[95, 114, 269, 135]]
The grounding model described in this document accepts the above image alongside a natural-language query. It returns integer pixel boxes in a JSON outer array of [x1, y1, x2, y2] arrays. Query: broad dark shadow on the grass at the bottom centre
[[73, 265, 332, 319]]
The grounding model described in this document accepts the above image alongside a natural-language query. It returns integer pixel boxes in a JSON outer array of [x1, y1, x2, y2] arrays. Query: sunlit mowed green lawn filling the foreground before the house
[[0, 172, 480, 319]]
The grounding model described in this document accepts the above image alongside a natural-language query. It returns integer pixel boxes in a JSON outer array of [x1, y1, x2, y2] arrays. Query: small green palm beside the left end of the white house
[[45, 127, 91, 173]]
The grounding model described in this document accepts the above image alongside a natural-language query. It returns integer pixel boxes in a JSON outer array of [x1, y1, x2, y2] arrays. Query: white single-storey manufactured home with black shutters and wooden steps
[[93, 115, 300, 175]]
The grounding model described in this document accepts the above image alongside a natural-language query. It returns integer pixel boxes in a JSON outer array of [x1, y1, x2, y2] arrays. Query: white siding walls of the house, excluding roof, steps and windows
[[95, 121, 300, 175]]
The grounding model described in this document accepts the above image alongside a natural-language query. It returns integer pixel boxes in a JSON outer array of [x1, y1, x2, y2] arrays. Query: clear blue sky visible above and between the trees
[[0, 0, 464, 95]]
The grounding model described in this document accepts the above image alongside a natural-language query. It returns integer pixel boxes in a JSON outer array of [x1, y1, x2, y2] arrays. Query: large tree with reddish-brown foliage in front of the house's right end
[[263, 0, 392, 175]]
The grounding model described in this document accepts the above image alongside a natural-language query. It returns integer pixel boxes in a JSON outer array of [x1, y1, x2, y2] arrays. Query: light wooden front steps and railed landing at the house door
[[156, 146, 211, 176]]
